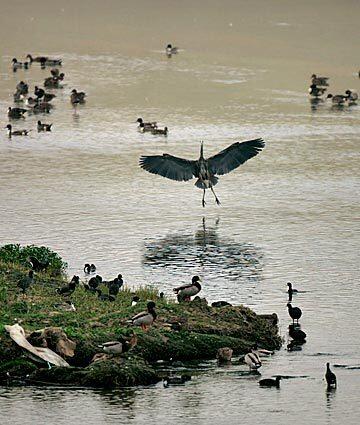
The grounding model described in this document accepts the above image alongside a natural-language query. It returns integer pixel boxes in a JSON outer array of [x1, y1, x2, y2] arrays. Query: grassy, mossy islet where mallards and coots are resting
[[0, 245, 281, 388]]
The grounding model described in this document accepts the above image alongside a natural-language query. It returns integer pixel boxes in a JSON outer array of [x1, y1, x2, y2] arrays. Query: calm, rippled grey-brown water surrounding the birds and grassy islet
[[0, 0, 360, 425]]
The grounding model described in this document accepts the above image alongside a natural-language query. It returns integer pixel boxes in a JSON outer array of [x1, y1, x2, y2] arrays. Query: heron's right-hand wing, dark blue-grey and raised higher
[[207, 139, 265, 175]]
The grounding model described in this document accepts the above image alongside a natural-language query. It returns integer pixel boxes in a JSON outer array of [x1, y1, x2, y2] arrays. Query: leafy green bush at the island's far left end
[[0, 244, 67, 275]]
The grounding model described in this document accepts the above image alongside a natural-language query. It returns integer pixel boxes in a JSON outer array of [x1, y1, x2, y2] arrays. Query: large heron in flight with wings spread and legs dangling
[[139, 139, 265, 207]]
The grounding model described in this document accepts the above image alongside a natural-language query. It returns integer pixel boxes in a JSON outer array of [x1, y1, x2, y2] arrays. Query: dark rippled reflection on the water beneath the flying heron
[[142, 218, 263, 281]]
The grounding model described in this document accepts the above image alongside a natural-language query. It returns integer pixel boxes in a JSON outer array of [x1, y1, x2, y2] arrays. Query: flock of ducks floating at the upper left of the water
[[5, 54, 86, 138]]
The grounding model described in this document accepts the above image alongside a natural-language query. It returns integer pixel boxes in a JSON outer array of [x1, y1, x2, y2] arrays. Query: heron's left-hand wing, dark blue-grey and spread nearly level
[[139, 153, 196, 181]]
